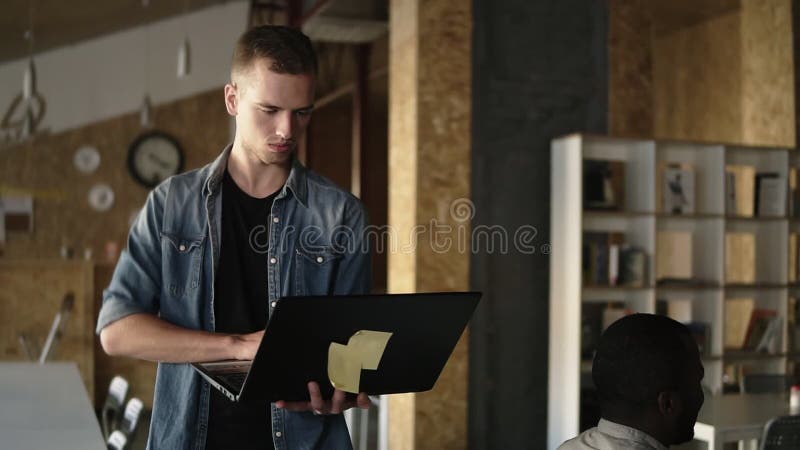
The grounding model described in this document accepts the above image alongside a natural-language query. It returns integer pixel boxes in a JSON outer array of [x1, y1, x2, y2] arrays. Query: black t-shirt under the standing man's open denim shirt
[[206, 171, 280, 450]]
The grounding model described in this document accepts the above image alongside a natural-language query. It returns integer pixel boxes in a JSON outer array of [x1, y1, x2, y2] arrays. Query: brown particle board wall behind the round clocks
[[0, 88, 230, 260]]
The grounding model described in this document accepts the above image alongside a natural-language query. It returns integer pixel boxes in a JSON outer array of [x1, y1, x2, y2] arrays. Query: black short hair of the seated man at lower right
[[592, 314, 695, 410]]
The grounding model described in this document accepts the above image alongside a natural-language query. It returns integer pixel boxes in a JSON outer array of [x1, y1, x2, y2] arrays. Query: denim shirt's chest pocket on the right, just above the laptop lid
[[294, 247, 342, 295]]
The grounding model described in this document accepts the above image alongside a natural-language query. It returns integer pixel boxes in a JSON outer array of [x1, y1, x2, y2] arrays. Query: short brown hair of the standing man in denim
[[231, 25, 317, 75]]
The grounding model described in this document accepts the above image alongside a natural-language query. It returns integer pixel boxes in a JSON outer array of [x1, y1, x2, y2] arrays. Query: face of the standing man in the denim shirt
[[225, 58, 314, 164]]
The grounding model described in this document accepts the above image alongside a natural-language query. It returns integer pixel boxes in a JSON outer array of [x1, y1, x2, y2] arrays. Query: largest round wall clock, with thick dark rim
[[128, 131, 183, 188]]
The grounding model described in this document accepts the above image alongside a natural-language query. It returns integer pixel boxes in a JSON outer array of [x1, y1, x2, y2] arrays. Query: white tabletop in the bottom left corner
[[0, 362, 106, 450]]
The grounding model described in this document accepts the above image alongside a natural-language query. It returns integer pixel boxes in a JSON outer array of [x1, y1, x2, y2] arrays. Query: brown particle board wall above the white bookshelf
[[609, 0, 796, 147]]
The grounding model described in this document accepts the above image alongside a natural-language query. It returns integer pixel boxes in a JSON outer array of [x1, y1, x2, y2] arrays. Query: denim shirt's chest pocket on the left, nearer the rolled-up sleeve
[[161, 233, 205, 299]]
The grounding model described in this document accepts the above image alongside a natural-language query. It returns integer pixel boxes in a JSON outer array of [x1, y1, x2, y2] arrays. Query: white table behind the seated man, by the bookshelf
[[694, 394, 789, 450]]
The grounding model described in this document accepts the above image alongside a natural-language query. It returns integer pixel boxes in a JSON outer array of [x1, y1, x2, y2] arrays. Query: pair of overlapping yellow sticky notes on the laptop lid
[[328, 330, 392, 394]]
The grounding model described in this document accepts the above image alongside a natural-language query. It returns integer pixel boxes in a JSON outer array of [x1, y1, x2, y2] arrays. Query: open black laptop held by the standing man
[[192, 292, 481, 402]]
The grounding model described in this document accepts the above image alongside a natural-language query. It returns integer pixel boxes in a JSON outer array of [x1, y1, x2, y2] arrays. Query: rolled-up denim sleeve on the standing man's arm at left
[[96, 182, 169, 334]]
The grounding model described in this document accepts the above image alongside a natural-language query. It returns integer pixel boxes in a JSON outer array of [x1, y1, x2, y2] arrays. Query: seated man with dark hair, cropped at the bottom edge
[[559, 314, 704, 450]]
